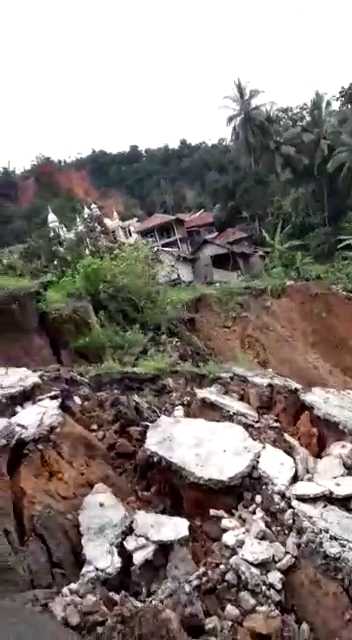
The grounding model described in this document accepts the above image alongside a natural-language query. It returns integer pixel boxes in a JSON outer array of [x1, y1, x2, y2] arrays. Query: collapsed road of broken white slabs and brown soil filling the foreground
[[0, 368, 352, 640]]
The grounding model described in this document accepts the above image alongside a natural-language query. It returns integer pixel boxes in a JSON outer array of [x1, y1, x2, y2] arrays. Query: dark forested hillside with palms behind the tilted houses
[[0, 79, 352, 261]]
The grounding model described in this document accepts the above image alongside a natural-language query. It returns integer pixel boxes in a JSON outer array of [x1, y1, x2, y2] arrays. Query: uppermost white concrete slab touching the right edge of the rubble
[[299, 387, 352, 433]]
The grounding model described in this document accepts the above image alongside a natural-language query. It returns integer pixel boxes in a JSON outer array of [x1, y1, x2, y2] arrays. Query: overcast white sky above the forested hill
[[0, 0, 352, 169]]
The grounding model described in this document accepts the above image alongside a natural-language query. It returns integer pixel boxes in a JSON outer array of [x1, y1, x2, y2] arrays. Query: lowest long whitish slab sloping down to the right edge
[[292, 500, 352, 543]]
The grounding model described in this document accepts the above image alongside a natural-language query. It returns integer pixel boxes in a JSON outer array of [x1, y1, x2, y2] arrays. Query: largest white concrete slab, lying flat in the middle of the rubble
[[145, 416, 263, 487]]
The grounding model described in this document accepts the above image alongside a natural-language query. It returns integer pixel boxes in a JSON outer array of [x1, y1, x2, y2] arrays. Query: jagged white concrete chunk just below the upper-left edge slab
[[11, 398, 64, 441]]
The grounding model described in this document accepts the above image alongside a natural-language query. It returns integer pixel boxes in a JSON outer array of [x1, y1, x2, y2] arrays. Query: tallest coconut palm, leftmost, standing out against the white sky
[[224, 78, 268, 169]]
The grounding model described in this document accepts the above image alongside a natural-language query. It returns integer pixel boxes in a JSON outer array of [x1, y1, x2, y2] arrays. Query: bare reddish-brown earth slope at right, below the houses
[[195, 283, 352, 388]]
